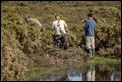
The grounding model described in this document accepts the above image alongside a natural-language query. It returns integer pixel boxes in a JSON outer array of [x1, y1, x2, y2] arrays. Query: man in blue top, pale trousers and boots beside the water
[[82, 13, 96, 58]]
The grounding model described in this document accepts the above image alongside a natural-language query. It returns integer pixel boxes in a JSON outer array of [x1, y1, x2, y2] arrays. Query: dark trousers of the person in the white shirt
[[53, 34, 67, 50]]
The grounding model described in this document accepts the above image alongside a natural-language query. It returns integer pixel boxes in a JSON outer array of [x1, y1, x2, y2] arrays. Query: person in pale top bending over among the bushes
[[25, 17, 45, 31]]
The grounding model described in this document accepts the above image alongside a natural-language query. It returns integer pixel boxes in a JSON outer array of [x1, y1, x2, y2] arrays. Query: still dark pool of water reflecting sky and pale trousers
[[27, 64, 121, 81]]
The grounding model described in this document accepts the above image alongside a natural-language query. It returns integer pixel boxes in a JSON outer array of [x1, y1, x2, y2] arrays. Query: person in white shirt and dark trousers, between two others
[[52, 15, 67, 50]]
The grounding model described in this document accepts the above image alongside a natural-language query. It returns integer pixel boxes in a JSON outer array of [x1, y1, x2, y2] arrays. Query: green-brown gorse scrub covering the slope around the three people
[[1, 1, 121, 81]]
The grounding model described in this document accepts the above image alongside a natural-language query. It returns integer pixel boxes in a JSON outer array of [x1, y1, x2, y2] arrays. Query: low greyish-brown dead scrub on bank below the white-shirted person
[[28, 48, 89, 67]]
